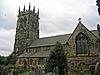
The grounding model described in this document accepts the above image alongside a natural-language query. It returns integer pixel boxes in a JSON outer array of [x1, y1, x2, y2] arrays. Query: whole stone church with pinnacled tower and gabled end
[[13, 4, 100, 70]]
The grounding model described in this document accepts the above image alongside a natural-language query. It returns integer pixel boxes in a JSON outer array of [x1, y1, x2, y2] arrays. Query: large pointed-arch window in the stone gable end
[[76, 33, 89, 54]]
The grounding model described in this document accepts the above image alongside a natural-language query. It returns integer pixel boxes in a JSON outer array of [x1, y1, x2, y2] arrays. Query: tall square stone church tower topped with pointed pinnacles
[[14, 3, 39, 55]]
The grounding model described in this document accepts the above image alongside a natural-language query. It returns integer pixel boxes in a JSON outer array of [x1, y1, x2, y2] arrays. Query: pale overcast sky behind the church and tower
[[0, 0, 100, 56]]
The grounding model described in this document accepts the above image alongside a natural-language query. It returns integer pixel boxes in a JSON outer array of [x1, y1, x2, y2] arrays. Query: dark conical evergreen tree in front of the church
[[47, 42, 67, 75]]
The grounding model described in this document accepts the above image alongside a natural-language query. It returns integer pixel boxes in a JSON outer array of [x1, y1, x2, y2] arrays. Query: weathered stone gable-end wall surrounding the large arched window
[[67, 22, 99, 70]]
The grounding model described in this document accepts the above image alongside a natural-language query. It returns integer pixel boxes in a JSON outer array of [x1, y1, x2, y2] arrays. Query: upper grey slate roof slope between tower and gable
[[30, 34, 71, 47]]
